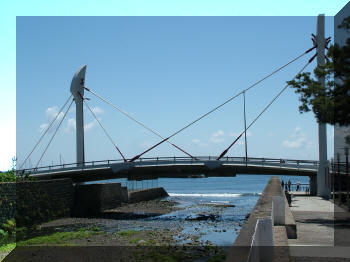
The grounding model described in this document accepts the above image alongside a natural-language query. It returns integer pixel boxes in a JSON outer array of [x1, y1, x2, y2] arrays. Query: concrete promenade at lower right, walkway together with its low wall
[[226, 177, 350, 262]]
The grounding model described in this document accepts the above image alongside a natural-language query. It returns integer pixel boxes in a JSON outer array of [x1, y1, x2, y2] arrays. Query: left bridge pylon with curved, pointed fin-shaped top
[[70, 65, 86, 166]]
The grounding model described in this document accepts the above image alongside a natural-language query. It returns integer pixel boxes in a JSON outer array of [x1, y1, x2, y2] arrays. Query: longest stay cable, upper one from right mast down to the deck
[[130, 46, 316, 162]]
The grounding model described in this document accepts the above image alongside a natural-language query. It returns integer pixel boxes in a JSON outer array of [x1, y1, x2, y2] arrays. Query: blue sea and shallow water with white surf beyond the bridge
[[98, 175, 309, 246]]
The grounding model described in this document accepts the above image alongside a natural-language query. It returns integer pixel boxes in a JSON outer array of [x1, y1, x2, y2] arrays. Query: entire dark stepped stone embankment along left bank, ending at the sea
[[0, 178, 168, 226]]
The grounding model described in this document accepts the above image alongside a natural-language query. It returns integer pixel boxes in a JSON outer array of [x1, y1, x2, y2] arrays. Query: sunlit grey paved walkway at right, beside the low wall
[[288, 195, 350, 261]]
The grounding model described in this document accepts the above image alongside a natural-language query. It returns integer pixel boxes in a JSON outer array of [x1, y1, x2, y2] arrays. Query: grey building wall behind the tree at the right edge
[[334, 2, 350, 162]]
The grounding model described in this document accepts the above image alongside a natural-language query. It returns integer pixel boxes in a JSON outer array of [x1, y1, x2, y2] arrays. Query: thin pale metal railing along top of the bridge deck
[[17, 156, 318, 173]]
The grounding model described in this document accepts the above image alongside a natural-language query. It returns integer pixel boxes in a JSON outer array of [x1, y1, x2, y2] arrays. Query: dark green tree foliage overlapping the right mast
[[287, 17, 350, 128]]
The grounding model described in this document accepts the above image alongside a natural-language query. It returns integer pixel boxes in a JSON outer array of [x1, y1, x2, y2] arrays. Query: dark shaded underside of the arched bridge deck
[[33, 164, 316, 183]]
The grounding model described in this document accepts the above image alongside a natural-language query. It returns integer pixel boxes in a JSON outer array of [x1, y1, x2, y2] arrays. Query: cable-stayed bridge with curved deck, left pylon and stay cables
[[17, 25, 330, 195]]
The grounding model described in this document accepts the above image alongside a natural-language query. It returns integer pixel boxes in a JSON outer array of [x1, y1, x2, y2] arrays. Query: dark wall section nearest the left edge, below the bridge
[[0, 179, 74, 226]]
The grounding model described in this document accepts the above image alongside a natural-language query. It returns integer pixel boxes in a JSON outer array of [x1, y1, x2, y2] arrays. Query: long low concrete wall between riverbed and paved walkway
[[226, 177, 296, 262]]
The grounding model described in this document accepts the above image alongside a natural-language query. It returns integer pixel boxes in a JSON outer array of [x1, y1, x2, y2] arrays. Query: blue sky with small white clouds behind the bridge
[[0, 1, 346, 170]]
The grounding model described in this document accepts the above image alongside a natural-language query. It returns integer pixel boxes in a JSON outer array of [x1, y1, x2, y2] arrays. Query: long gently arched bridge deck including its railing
[[18, 157, 318, 182]]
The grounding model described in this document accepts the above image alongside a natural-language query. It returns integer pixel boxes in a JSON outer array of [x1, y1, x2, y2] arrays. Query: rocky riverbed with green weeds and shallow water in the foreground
[[5, 198, 244, 261]]
